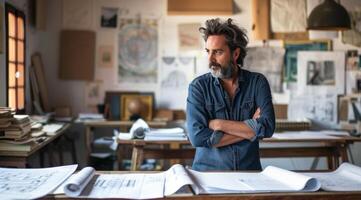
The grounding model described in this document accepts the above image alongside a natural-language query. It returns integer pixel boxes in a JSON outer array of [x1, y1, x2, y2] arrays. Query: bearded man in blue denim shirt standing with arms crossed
[[187, 18, 275, 171]]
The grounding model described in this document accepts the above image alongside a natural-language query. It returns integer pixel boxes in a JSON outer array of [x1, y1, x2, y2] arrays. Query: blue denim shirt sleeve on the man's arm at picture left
[[186, 83, 223, 148]]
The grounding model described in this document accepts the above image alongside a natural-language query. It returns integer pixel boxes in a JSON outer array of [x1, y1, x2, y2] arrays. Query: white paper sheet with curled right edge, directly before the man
[[189, 166, 320, 194]]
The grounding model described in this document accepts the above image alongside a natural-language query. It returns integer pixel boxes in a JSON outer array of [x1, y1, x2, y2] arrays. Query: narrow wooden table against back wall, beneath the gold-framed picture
[[83, 120, 167, 166]]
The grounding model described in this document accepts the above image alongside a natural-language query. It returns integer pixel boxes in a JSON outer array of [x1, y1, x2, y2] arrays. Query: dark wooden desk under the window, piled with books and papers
[[0, 124, 70, 168]]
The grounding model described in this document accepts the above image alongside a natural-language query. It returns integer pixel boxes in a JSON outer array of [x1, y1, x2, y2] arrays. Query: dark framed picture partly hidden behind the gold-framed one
[[105, 91, 139, 120]]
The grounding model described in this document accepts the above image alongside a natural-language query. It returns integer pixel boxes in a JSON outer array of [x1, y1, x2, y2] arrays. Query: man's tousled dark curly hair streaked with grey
[[199, 18, 248, 66]]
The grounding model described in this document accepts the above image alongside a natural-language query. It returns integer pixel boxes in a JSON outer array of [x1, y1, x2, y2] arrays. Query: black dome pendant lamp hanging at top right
[[307, 0, 351, 31]]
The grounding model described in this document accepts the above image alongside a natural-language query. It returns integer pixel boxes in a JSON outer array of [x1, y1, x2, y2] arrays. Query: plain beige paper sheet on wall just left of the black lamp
[[271, 0, 307, 32]]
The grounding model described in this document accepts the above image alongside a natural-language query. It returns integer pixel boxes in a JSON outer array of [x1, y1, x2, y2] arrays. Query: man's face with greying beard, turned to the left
[[206, 35, 238, 79]]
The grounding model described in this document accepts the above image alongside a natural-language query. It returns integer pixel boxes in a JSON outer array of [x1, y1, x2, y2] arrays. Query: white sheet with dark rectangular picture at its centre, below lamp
[[297, 51, 345, 94]]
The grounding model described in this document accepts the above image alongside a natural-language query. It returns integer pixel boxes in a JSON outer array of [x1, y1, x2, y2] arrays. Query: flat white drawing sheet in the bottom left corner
[[0, 165, 78, 199]]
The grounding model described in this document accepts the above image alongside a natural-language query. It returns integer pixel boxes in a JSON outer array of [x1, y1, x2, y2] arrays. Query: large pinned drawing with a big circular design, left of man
[[118, 19, 158, 83]]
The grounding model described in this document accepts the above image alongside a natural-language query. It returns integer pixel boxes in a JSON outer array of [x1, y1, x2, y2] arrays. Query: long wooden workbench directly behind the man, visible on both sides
[[117, 136, 361, 170]]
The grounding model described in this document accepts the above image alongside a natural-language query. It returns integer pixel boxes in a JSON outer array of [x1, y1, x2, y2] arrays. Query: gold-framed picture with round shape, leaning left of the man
[[120, 93, 154, 121]]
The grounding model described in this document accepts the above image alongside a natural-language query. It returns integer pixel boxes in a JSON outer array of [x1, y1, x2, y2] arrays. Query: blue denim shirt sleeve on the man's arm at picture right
[[255, 75, 275, 139]]
